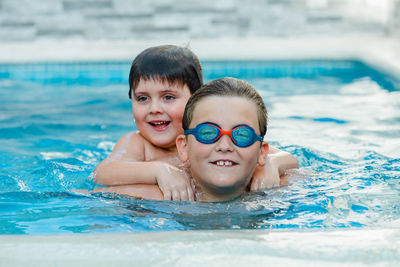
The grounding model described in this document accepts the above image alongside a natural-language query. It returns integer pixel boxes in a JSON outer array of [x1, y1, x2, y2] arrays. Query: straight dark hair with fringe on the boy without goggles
[[129, 45, 203, 98]]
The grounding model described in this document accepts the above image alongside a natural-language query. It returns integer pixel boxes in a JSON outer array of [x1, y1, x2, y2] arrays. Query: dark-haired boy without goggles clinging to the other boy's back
[[94, 45, 297, 200]]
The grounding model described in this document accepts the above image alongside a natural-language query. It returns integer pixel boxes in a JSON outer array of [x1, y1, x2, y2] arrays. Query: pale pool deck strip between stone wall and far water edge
[[0, 35, 400, 77]]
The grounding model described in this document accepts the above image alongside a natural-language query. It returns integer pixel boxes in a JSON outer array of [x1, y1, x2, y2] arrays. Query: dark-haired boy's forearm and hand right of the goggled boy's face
[[250, 146, 298, 191]]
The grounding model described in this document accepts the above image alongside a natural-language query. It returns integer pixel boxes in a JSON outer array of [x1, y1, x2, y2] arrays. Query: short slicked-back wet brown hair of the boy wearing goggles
[[182, 77, 268, 136]]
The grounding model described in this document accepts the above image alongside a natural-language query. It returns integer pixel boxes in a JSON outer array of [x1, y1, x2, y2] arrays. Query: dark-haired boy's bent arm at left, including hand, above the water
[[93, 133, 193, 200]]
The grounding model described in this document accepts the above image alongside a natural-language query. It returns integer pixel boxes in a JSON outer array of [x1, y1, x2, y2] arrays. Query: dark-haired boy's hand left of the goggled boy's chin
[[156, 162, 194, 201]]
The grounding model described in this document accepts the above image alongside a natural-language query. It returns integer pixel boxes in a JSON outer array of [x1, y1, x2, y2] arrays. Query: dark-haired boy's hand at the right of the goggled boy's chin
[[250, 156, 280, 191]]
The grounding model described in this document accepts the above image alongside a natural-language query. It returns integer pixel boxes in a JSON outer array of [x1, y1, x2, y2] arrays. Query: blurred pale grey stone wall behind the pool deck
[[0, 0, 400, 42]]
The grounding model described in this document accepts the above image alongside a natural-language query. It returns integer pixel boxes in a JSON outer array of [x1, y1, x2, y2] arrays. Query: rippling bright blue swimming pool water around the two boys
[[0, 60, 400, 235]]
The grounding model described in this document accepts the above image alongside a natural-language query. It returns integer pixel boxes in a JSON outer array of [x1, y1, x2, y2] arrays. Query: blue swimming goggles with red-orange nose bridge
[[184, 122, 264, 147]]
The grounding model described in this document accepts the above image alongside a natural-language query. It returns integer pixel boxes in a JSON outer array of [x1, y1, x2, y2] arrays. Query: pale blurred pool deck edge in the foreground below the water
[[0, 229, 400, 267]]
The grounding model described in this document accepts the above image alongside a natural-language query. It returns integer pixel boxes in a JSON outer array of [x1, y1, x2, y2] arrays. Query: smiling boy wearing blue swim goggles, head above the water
[[176, 78, 268, 201]]
